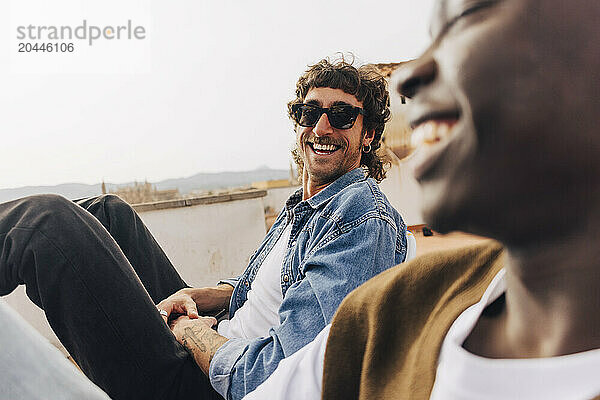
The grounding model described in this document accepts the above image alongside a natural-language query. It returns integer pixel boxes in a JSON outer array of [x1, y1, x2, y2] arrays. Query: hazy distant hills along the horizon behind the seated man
[[0, 167, 289, 203]]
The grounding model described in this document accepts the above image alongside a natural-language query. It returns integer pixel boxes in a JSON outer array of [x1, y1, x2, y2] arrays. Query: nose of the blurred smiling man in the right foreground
[[392, 50, 438, 98]]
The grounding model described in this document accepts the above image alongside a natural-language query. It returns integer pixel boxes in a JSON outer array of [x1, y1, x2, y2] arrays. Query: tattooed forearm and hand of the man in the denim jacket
[[170, 315, 228, 376]]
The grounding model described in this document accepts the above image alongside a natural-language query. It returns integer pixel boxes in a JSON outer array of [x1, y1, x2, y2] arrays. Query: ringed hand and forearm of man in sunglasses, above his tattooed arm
[[156, 285, 233, 323]]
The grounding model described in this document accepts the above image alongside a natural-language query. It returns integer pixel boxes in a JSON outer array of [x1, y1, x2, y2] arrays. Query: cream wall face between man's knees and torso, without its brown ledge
[[139, 198, 266, 286]]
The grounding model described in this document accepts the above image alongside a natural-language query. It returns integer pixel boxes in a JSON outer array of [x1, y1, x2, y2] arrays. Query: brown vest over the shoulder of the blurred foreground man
[[323, 241, 504, 398]]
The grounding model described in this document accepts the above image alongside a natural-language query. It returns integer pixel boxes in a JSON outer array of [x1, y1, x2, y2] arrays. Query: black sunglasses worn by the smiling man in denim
[[292, 103, 366, 129]]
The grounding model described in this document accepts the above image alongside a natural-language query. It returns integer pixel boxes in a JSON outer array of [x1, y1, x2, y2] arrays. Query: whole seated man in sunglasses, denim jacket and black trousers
[[0, 56, 414, 399]]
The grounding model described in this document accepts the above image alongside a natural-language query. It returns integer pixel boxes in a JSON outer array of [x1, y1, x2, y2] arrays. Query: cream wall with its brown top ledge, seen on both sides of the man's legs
[[3, 191, 266, 351]]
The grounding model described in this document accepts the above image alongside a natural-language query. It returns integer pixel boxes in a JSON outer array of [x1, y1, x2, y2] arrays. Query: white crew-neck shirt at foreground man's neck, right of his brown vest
[[430, 270, 600, 400]]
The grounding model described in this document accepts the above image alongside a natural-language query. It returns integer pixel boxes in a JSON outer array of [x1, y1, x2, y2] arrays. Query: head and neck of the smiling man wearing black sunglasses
[[288, 60, 390, 198]]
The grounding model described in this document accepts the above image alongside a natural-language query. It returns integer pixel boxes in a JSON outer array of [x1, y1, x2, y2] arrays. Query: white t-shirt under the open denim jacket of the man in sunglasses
[[217, 223, 292, 339]]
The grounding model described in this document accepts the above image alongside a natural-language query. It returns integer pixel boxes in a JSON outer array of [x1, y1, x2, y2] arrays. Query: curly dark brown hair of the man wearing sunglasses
[[288, 56, 390, 182]]
